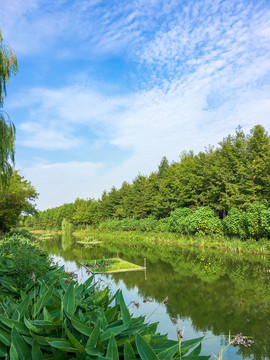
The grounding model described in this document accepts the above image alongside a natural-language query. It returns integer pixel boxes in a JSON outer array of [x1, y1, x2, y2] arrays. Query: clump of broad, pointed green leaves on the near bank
[[0, 269, 209, 360]]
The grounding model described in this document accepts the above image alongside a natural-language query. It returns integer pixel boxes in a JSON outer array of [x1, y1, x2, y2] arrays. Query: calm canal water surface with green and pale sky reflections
[[41, 236, 270, 360]]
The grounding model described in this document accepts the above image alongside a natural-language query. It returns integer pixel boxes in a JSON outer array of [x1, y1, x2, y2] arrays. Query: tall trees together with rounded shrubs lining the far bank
[[24, 125, 270, 238]]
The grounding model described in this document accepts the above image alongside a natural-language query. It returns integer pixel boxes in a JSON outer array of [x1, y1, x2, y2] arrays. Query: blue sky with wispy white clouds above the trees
[[0, 0, 270, 210]]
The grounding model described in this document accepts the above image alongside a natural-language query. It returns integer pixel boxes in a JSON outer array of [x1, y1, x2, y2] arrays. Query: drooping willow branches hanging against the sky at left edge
[[0, 31, 17, 183]]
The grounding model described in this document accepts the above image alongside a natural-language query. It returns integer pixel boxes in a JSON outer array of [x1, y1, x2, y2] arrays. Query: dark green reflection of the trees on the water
[[39, 239, 270, 359]]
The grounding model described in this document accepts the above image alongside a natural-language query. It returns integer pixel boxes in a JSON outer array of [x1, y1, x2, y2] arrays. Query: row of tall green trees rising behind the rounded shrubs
[[26, 125, 270, 232]]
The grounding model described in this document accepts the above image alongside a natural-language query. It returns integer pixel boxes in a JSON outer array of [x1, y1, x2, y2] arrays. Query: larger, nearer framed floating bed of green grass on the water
[[78, 258, 146, 274]]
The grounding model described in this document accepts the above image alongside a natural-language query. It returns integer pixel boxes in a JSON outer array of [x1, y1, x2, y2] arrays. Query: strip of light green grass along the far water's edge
[[73, 229, 270, 255]]
